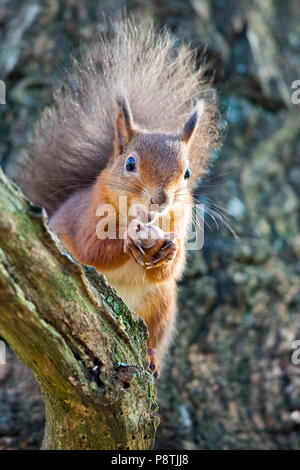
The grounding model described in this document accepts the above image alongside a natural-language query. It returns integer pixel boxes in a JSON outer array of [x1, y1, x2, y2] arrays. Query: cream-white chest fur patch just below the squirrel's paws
[[102, 259, 153, 310]]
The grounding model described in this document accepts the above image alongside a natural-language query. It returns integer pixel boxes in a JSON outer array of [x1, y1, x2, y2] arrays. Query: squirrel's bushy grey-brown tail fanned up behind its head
[[15, 19, 218, 213]]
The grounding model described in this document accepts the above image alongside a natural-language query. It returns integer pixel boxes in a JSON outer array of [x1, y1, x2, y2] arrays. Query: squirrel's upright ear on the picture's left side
[[114, 96, 134, 155]]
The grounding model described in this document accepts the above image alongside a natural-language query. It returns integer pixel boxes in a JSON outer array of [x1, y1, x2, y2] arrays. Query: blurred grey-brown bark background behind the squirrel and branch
[[0, 0, 300, 449]]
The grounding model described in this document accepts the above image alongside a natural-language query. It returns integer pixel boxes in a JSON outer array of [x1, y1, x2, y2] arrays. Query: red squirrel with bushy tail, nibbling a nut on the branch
[[15, 20, 218, 377]]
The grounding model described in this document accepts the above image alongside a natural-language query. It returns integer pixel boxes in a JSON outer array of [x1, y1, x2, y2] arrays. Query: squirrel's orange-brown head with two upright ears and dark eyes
[[100, 98, 201, 218]]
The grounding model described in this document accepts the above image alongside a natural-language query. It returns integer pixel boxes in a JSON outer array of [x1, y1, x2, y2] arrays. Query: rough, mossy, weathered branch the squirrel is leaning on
[[0, 172, 159, 449]]
